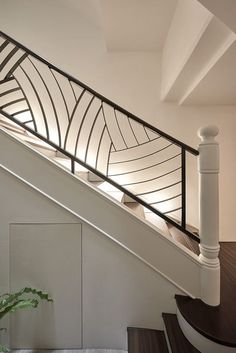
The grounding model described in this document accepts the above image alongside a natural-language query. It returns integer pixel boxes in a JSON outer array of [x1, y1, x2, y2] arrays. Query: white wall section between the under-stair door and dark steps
[[82, 221, 180, 349]]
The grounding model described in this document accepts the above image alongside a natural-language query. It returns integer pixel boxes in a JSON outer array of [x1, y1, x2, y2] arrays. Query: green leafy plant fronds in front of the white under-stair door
[[0, 287, 53, 353]]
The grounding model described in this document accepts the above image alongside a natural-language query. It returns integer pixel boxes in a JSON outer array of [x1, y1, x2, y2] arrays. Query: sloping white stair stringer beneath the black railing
[[0, 126, 201, 298]]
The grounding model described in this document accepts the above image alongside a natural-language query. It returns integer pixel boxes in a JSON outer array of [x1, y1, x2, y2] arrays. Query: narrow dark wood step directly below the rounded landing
[[162, 313, 200, 353]]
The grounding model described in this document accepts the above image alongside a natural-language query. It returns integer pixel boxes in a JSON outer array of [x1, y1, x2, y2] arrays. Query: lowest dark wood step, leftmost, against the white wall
[[127, 327, 168, 353]]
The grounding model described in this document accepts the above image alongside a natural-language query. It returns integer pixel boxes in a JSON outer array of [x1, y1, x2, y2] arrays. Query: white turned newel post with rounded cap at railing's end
[[198, 126, 220, 306]]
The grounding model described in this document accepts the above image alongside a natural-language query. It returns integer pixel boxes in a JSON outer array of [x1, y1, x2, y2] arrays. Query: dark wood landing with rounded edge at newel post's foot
[[176, 242, 236, 347]]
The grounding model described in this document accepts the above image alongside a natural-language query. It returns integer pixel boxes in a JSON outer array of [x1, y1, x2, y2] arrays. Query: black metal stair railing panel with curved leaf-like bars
[[0, 32, 199, 241]]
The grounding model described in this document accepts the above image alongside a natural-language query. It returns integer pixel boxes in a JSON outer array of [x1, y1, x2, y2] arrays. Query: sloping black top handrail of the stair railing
[[0, 31, 199, 156]]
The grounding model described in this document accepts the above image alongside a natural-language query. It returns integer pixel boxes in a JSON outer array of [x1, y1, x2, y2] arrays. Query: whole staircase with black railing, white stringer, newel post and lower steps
[[0, 32, 227, 353]]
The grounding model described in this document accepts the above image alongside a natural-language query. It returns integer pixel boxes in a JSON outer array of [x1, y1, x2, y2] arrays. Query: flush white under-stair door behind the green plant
[[10, 224, 82, 349]]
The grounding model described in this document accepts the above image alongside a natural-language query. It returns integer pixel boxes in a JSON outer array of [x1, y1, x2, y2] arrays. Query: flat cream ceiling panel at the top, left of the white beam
[[100, 0, 176, 51]]
